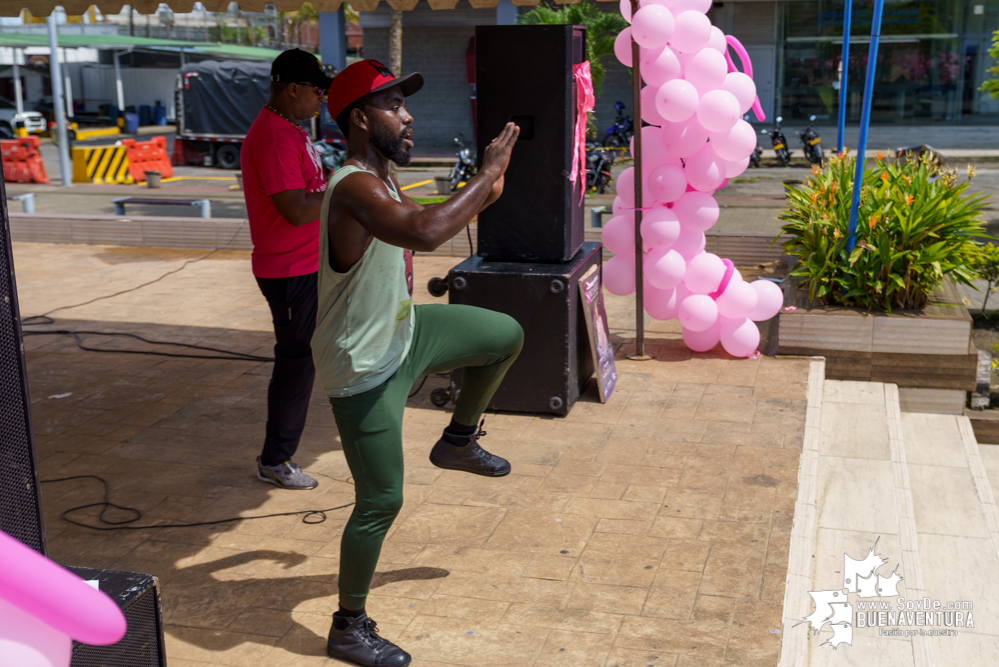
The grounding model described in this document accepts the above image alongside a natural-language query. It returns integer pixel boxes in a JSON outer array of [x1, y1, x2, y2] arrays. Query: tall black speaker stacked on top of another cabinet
[[475, 25, 586, 263]]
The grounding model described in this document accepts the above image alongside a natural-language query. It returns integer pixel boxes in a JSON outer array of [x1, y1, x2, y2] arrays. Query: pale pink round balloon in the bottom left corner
[[0, 599, 73, 667]]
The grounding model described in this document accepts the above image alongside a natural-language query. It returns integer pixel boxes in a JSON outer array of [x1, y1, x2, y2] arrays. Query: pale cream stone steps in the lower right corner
[[780, 378, 999, 667]]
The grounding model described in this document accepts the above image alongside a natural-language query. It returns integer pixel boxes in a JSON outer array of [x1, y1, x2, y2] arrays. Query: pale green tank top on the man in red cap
[[312, 166, 413, 398]]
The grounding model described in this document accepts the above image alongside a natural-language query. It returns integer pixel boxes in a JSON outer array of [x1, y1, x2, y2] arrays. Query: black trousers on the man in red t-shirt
[[257, 273, 318, 465]]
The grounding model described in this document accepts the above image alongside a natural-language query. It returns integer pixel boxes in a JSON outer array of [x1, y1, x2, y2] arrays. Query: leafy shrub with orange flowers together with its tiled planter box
[[774, 154, 988, 400]]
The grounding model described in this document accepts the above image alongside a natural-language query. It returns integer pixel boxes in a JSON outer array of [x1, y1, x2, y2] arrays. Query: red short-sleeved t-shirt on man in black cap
[[240, 107, 326, 278]]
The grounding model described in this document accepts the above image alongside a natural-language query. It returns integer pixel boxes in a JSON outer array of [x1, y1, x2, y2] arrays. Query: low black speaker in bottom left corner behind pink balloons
[[66, 567, 166, 667]]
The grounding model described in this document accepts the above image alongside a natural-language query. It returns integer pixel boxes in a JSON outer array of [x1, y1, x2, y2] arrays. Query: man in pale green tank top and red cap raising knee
[[312, 60, 524, 667]]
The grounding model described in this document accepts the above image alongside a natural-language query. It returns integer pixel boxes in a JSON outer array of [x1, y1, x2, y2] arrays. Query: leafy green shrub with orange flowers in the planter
[[775, 155, 987, 312]]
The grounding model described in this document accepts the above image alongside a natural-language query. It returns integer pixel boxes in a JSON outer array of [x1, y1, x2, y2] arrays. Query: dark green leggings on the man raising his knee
[[330, 304, 524, 609]]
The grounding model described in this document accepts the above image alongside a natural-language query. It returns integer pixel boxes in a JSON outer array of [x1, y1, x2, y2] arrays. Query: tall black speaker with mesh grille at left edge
[[0, 157, 45, 554]]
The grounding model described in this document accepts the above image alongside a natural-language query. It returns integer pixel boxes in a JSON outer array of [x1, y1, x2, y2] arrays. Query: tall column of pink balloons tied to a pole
[[603, 0, 783, 357]]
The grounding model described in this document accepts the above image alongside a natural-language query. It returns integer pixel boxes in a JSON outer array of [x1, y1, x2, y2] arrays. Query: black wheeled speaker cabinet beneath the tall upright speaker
[[448, 243, 603, 415]]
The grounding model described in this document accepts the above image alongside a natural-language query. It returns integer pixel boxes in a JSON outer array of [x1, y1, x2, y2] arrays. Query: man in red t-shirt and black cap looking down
[[240, 49, 332, 489]]
